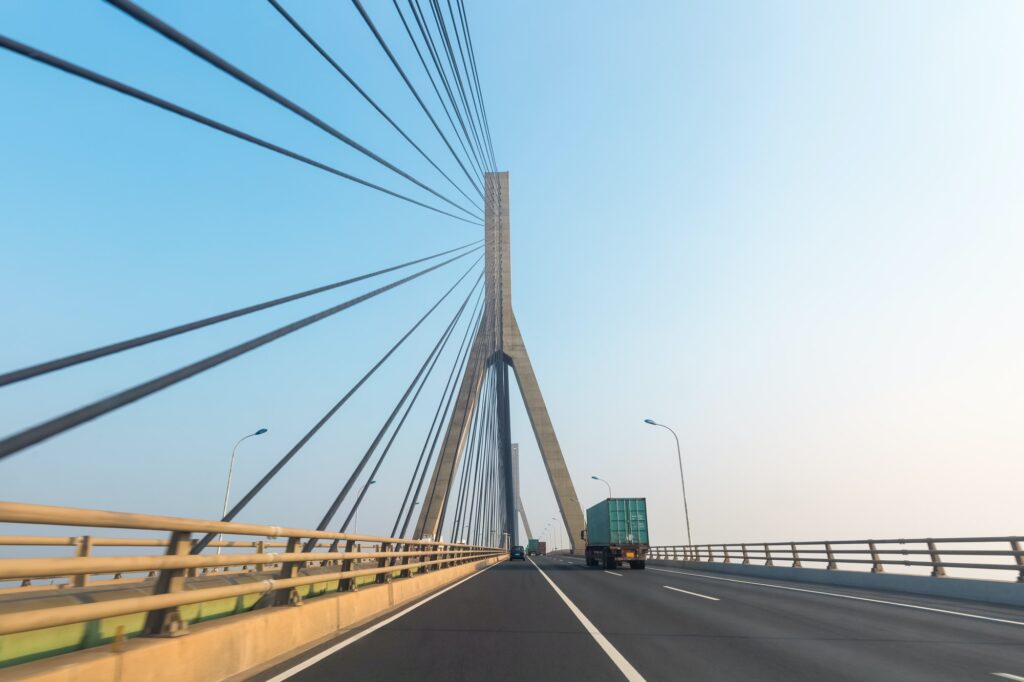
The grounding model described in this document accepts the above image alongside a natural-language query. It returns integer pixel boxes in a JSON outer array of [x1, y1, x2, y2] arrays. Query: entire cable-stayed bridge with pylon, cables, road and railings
[[0, 0, 1024, 681]]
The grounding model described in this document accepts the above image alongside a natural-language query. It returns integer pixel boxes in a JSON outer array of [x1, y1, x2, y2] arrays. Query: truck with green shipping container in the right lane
[[581, 498, 650, 569]]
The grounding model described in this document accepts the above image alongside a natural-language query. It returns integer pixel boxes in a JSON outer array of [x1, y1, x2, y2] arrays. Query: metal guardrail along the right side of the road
[[648, 536, 1024, 583]]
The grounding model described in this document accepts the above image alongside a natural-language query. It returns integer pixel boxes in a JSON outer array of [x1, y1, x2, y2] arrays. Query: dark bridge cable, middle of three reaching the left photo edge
[[0, 240, 482, 386]]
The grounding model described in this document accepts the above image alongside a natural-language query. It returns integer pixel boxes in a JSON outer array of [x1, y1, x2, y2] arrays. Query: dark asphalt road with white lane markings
[[256, 556, 1024, 682]]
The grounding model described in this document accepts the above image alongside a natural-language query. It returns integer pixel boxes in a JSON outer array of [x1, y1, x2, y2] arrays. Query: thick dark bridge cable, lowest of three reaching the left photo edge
[[0, 247, 480, 459]]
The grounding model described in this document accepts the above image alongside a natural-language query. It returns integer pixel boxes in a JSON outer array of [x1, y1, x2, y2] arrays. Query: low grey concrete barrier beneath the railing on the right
[[647, 559, 1024, 606]]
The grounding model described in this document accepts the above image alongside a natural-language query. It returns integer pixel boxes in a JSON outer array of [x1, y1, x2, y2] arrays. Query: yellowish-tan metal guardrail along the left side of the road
[[0, 502, 507, 636]]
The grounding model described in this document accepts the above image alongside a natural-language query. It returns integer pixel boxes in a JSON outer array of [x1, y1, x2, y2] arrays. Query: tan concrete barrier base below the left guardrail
[[0, 558, 499, 682]]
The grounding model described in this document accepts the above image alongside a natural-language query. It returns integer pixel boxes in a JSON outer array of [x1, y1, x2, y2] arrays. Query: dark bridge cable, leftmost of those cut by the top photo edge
[[106, 0, 476, 217]]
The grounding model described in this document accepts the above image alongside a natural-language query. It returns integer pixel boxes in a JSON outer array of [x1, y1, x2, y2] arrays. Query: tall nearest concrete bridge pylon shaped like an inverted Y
[[416, 172, 584, 552]]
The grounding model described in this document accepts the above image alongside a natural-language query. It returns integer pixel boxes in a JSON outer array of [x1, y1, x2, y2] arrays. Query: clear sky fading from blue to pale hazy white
[[0, 0, 1024, 545]]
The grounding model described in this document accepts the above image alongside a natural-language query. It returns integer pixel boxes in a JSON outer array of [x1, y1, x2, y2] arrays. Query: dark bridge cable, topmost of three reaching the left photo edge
[[0, 35, 483, 225]]
